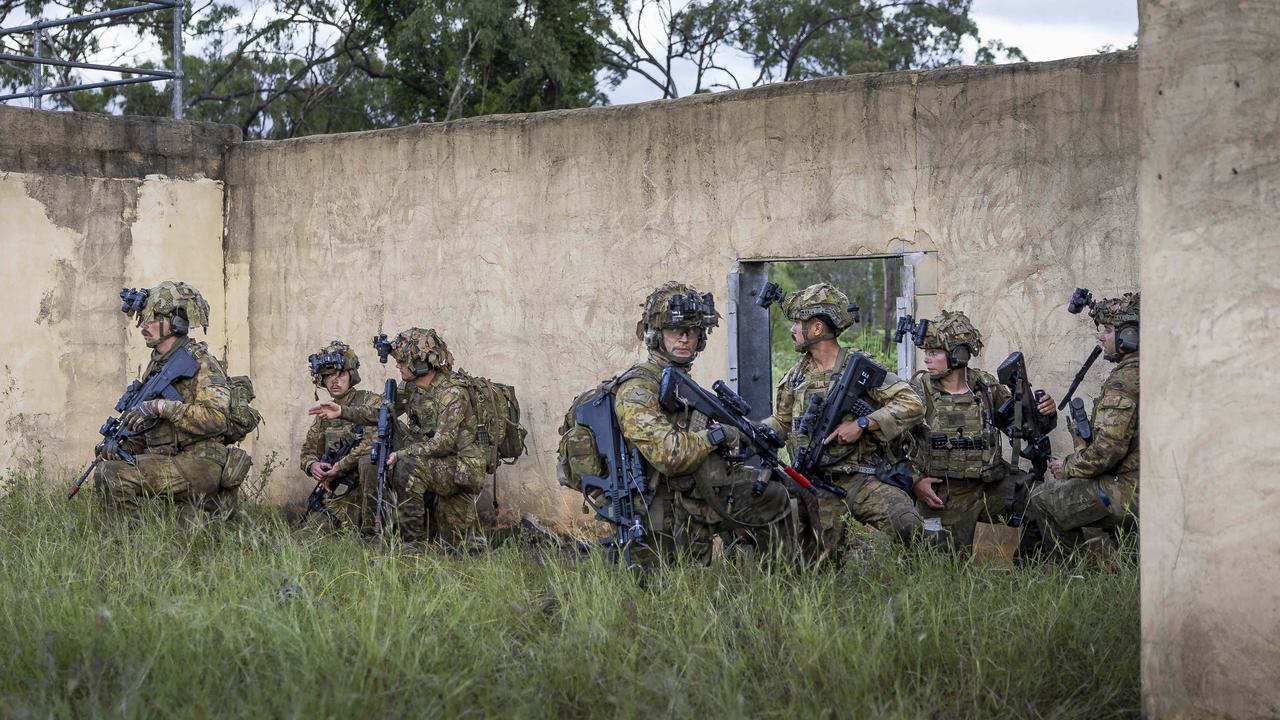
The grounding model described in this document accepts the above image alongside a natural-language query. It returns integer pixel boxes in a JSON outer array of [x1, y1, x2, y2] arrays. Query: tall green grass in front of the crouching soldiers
[[0, 475, 1139, 719]]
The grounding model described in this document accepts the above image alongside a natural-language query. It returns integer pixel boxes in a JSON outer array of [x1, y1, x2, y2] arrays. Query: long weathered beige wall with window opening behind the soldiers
[[227, 54, 1137, 516]]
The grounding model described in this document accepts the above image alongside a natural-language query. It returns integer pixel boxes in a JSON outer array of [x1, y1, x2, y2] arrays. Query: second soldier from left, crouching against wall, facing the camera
[[301, 340, 381, 528]]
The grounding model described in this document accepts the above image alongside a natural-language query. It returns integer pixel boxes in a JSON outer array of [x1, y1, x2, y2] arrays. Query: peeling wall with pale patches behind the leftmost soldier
[[0, 106, 239, 471]]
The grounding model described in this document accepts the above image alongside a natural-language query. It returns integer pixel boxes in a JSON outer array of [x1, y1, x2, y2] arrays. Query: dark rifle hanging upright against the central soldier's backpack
[[573, 392, 650, 565]]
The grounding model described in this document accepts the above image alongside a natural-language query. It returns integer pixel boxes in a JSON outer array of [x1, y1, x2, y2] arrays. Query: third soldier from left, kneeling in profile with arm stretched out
[[314, 328, 489, 548]]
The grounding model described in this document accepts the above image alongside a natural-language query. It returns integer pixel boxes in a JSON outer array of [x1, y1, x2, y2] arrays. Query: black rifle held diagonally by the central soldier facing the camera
[[658, 368, 849, 497]]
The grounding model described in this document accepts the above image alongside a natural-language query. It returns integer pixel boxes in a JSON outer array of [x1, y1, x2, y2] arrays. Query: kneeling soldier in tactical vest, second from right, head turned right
[[911, 311, 1057, 548]]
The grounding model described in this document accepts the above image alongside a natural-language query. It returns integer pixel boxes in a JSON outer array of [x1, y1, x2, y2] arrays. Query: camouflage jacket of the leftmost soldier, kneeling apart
[[125, 337, 232, 455]]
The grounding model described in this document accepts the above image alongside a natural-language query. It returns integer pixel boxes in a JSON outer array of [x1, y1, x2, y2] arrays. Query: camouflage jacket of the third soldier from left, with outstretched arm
[[337, 372, 489, 473]]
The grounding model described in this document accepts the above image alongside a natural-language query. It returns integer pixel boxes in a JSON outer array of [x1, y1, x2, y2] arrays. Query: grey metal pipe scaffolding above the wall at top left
[[0, 0, 184, 118]]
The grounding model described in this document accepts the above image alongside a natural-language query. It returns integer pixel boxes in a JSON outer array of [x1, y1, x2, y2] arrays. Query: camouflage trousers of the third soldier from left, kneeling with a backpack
[[358, 455, 485, 548]]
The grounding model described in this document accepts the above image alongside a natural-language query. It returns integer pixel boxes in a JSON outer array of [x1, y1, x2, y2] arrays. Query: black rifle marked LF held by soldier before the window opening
[[795, 351, 885, 477]]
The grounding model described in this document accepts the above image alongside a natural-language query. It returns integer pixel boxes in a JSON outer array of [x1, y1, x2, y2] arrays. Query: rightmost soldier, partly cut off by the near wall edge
[[1030, 292, 1140, 550]]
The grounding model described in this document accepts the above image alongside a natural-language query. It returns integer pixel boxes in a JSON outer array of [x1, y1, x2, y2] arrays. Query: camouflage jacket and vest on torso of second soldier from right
[[911, 368, 1012, 479]]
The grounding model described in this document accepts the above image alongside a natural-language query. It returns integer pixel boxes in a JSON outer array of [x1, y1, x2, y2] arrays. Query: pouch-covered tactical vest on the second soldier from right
[[920, 373, 1000, 479]]
